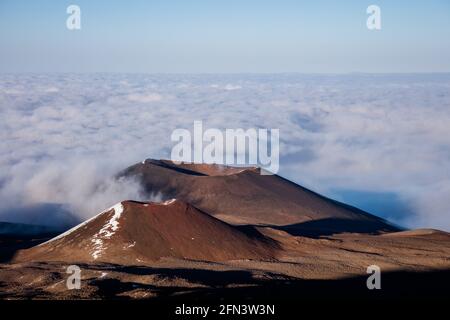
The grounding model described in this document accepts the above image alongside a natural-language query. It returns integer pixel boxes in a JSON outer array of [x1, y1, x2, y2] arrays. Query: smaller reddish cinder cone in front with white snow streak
[[15, 200, 278, 264]]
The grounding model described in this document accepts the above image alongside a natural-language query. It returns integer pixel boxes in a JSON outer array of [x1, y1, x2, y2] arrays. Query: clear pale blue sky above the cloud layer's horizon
[[0, 0, 450, 73]]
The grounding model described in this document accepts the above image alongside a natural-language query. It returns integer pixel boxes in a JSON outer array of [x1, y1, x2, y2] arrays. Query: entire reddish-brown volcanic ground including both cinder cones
[[0, 160, 450, 303]]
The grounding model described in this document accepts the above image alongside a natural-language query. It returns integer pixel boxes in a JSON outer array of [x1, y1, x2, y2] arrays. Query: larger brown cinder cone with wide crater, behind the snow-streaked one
[[120, 159, 398, 233]]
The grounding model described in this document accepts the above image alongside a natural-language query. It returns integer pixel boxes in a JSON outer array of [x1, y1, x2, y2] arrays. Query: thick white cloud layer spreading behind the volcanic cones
[[0, 74, 450, 230]]
